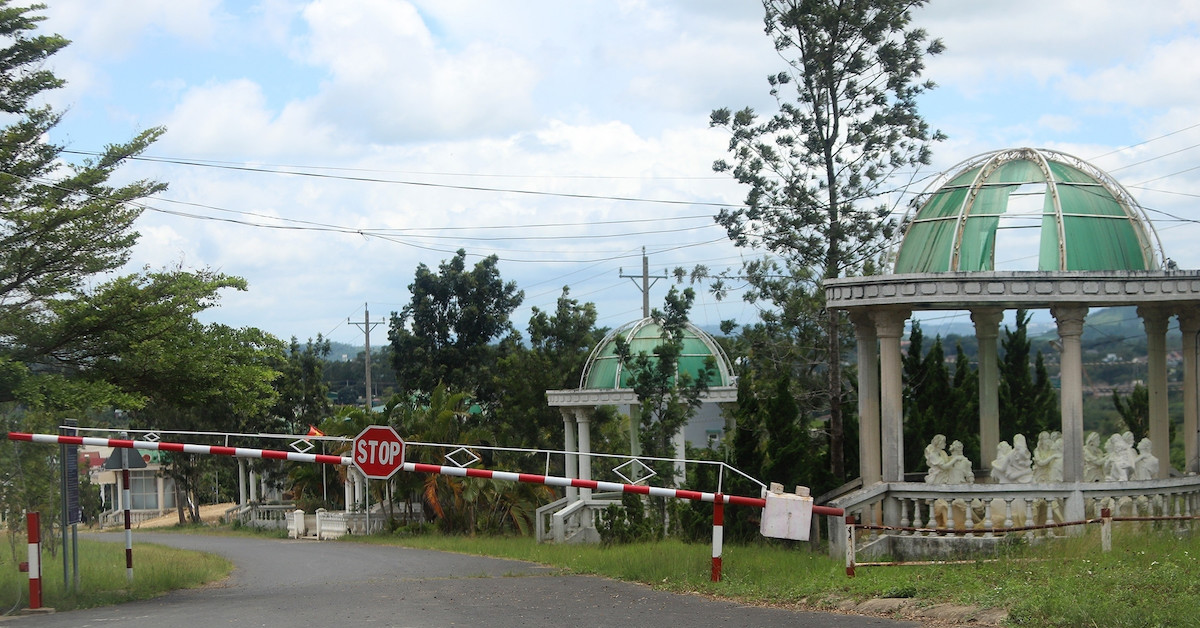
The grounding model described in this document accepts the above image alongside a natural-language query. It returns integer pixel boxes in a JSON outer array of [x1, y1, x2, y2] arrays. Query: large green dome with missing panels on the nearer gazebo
[[895, 148, 1160, 274]]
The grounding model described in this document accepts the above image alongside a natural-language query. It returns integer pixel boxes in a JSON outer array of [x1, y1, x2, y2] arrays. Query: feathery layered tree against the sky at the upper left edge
[[0, 1, 166, 362]]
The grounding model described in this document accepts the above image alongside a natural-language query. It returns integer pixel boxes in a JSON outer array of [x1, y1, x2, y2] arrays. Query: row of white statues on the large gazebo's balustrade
[[925, 432, 1158, 484]]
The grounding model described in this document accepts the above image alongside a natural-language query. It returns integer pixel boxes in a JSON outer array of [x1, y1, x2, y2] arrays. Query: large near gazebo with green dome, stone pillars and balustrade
[[824, 148, 1200, 559]]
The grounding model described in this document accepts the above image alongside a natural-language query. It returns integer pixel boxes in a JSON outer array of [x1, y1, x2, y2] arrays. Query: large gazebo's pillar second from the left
[[871, 310, 910, 482]]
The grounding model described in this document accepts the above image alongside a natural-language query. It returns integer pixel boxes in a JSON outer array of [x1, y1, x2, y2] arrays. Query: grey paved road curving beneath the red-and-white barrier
[[7, 533, 917, 628]]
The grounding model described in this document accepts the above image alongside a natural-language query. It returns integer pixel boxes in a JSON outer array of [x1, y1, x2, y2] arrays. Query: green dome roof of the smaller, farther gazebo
[[580, 317, 733, 390]]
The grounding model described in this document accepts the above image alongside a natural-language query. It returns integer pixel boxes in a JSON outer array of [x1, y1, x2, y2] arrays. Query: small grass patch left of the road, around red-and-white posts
[[0, 538, 233, 614]]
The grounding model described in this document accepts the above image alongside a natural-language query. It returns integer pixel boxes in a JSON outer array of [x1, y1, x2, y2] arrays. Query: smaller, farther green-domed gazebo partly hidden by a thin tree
[[538, 317, 737, 542]]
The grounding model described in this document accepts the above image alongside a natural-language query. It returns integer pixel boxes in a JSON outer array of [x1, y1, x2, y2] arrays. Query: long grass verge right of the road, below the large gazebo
[[360, 526, 1200, 627]]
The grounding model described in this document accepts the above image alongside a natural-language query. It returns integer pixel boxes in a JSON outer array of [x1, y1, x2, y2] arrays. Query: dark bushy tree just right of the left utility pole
[[388, 249, 524, 401]]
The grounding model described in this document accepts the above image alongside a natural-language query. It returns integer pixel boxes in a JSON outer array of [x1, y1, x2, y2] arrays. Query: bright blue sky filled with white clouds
[[30, 0, 1200, 346]]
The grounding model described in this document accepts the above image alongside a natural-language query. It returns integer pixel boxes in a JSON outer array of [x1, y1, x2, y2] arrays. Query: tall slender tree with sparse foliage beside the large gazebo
[[710, 0, 942, 478]]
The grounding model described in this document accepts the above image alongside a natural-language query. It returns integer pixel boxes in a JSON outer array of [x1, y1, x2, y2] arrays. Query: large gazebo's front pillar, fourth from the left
[[1050, 305, 1087, 482]]
